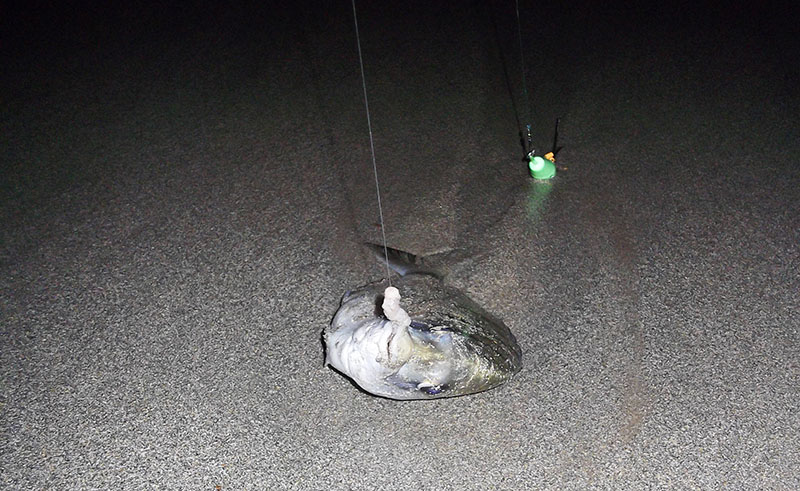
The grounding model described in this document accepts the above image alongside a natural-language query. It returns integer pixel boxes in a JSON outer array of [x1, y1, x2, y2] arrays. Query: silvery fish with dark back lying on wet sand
[[323, 243, 522, 400]]
